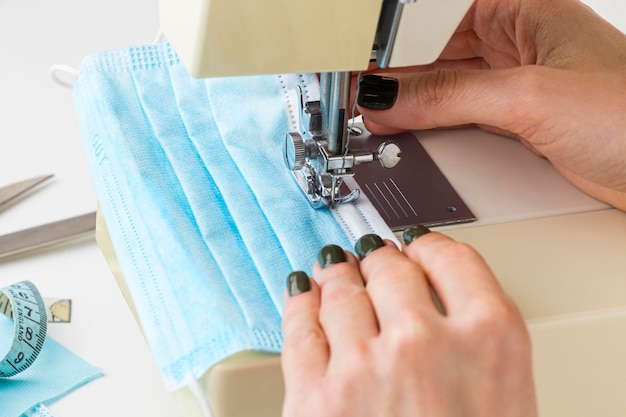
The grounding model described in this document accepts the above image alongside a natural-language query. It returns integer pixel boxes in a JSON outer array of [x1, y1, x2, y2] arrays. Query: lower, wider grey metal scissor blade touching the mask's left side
[[0, 212, 96, 260]]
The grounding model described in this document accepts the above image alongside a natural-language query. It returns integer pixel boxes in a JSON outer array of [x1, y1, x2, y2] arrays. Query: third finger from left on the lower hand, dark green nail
[[357, 235, 437, 329]]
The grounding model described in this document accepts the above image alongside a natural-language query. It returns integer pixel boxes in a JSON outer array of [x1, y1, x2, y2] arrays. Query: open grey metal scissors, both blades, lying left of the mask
[[0, 175, 96, 261]]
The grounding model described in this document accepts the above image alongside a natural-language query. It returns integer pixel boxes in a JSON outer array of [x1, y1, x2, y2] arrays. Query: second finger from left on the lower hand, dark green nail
[[313, 246, 378, 353]]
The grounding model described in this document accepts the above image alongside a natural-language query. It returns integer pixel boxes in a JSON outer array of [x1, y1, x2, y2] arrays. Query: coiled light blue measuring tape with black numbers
[[0, 281, 47, 378]]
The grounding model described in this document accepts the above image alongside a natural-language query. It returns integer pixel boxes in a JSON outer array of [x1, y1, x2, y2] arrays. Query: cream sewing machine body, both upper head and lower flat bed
[[98, 0, 626, 417]]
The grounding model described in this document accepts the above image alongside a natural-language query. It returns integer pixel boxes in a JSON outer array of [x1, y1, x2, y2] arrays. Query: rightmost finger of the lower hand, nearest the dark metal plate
[[403, 233, 508, 317]]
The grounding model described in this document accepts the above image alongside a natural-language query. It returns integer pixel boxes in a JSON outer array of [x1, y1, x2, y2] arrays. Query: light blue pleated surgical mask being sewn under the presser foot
[[74, 43, 394, 390]]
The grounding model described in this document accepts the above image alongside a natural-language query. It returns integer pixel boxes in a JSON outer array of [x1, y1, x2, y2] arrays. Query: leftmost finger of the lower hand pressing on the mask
[[281, 273, 329, 386]]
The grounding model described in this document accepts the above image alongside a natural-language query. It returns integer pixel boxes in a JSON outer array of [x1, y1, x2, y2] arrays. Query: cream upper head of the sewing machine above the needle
[[159, 0, 473, 77]]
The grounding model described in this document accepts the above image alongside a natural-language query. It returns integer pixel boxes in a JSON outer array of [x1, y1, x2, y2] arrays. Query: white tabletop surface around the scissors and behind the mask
[[0, 0, 626, 417]]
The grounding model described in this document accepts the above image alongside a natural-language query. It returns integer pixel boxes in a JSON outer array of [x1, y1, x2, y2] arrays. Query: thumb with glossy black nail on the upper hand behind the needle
[[357, 67, 541, 136]]
